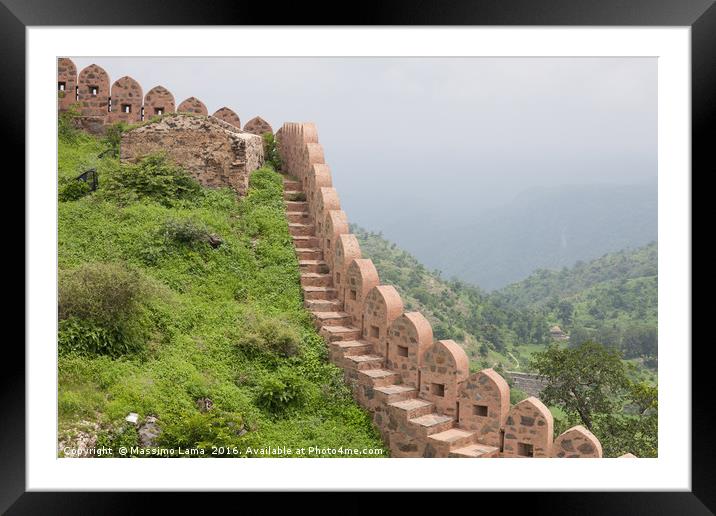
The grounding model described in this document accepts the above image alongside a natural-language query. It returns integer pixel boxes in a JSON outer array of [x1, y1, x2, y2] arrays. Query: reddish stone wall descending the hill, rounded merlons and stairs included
[[276, 122, 624, 458]]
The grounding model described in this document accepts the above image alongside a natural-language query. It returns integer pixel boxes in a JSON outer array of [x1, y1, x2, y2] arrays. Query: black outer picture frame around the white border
[[5, 0, 716, 515]]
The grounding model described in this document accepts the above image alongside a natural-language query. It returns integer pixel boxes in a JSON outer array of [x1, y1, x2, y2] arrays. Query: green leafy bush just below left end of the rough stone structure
[[104, 152, 202, 207]]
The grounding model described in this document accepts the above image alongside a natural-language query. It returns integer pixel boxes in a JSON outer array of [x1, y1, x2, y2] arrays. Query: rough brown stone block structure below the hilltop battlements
[[120, 114, 264, 195]]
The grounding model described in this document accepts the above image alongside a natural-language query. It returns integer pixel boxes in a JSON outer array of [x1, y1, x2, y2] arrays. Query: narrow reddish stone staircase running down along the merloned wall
[[284, 180, 499, 458]]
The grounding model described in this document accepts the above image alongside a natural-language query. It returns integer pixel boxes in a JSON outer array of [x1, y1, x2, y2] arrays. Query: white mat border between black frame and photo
[[26, 27, 691, 491]]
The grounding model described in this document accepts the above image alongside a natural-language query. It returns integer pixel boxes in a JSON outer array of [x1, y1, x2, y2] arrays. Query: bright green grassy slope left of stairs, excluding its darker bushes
[[58, 131, 383, 456]]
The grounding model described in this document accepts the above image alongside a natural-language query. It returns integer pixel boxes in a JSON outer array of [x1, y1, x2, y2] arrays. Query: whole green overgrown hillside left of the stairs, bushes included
[[58, 119, 387, 456]]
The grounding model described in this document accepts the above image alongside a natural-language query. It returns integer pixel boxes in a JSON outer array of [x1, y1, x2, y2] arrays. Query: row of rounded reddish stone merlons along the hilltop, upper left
[[57, 57, 273, 135]]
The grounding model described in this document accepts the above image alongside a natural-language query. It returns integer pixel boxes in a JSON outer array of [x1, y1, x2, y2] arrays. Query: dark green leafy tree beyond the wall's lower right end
[[531, 341, 629, 430]]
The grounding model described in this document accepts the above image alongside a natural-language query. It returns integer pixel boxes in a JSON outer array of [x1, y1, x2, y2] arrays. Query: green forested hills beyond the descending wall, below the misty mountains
[[351, 225, 657, 379]]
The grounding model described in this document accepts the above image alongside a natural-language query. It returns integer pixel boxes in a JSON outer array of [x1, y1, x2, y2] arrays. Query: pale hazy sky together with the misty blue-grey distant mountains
[[73, 57, 657, 290]]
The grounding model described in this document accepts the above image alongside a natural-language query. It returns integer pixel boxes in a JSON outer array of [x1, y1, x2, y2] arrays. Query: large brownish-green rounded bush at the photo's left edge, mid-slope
[[58, 263, 161, 357]]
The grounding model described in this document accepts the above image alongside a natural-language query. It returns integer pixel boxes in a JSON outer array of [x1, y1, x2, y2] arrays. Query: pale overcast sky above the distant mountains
[[72, 57, 657, 236]]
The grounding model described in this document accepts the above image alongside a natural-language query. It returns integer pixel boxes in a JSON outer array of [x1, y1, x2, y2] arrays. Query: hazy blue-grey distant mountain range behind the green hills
[[384, 183, 657, 291]]
